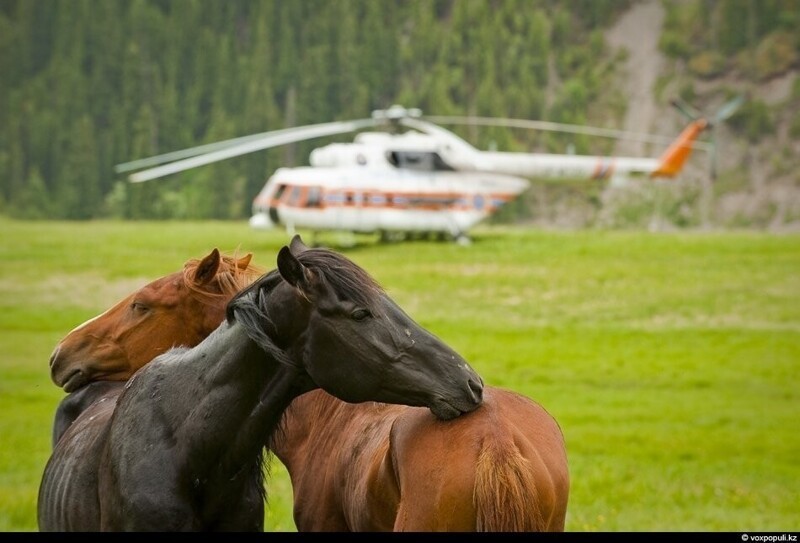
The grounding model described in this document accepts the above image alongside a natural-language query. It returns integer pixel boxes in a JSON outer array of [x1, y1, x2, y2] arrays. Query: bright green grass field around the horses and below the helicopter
[[0, 219, 800, 532]]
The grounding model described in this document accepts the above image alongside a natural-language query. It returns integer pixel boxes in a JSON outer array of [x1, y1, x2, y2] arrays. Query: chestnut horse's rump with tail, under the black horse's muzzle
[[391, 387, 569, 531]]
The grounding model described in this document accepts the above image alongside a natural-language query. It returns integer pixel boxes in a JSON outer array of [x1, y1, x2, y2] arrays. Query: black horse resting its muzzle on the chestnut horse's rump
[[38, 237, 483, 531]]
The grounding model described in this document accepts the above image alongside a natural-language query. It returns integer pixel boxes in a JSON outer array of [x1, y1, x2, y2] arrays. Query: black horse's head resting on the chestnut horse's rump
[[228, 236, 483, 419]]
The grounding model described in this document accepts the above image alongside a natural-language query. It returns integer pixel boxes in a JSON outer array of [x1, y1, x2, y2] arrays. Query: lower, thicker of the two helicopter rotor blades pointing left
[[123, 119, 381, 183]]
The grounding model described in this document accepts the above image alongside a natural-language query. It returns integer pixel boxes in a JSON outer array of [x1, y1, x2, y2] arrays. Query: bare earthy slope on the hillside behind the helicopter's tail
[[606, 0, 800, 231]]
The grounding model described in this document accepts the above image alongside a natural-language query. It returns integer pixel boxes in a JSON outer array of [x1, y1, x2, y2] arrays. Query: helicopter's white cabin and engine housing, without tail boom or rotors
[[250, 132, 529, 238]]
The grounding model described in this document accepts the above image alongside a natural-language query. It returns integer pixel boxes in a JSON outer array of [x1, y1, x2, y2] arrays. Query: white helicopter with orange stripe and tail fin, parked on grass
[[116, 101, 732, 245]]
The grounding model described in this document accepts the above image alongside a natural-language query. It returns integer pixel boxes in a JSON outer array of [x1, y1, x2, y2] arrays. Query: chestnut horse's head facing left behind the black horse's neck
[[50, 249, 263, 392]]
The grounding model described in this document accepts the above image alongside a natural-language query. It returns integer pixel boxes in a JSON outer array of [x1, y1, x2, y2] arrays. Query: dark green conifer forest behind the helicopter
[[0, 0, 800, 226]]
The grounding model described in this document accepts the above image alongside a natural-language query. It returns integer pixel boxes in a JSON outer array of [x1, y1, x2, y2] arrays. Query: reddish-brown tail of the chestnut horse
[[472, 440, 545, 532]]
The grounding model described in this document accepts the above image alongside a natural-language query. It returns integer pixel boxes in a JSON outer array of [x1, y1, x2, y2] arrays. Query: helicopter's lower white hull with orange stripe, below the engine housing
[[250, 166, 528, 237]]
